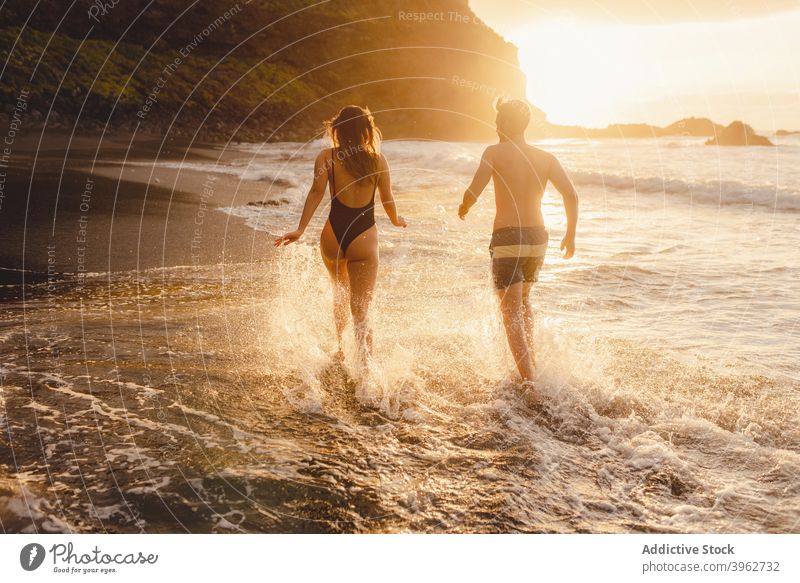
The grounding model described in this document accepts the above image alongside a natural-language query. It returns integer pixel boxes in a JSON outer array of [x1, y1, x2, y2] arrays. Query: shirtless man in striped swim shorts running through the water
[[458, 100, 578, 402]]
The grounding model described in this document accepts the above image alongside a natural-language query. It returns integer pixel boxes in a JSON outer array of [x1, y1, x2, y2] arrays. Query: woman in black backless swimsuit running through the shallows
[[275, 105, 406, 364]]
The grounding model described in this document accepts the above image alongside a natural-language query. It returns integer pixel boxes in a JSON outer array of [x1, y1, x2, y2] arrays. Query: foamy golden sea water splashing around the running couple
[[0, 137, 800, 532]]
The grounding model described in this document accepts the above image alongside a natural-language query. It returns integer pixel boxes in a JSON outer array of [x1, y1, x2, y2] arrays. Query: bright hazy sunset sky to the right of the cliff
[[470, 0, 800, 131]]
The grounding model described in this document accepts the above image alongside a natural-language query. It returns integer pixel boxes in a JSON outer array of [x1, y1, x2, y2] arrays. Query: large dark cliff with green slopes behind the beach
[[0, 0, 525, 140]]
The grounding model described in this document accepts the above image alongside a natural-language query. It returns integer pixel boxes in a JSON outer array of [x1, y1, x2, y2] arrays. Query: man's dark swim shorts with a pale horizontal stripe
[[489, 225, 549, 289]]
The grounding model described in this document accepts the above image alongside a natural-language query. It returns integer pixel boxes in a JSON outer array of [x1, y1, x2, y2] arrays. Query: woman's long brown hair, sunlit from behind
[[325, 105, 381, 179]]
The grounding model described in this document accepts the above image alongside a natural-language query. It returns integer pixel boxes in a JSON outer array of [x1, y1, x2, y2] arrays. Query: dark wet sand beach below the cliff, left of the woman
[[0, 134, 270, 284]]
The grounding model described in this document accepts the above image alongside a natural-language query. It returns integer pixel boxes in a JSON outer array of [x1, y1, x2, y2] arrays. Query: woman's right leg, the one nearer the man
[[347, 226, 378, 363]]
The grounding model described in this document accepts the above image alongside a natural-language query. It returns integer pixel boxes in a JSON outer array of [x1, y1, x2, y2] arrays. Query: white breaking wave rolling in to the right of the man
[[570, 170, 800, 211]]
